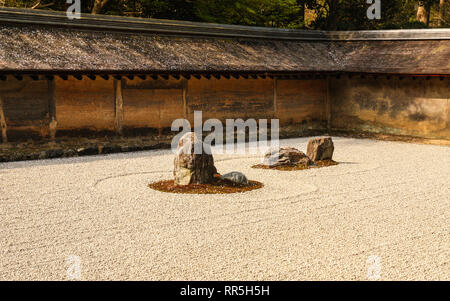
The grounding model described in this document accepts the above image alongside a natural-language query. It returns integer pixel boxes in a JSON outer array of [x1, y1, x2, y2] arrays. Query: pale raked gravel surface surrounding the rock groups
[[0, 138, 450, 280]]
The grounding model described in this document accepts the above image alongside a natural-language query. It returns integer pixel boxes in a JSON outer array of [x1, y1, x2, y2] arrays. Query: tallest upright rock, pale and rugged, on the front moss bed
[[173, 132, 217, 185]]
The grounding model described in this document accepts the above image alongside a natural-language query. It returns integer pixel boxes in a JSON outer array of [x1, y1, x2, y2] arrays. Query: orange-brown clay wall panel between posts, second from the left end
[[54, 77, 114, 132]]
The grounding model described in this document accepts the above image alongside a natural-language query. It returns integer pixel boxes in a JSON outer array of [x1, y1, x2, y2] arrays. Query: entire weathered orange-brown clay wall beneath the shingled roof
[[0, 76, 450, 140]]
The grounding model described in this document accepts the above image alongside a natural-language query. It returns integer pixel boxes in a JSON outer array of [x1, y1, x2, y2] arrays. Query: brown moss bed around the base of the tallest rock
[[148, 176, 264, 194]]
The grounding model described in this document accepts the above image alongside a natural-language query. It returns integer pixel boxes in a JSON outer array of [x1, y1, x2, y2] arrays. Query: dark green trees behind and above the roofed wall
[[0, 0, 450, 30]]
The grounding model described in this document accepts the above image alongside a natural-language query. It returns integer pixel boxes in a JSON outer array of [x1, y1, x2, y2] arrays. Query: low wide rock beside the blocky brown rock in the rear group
[[263, 147, 312, 167]]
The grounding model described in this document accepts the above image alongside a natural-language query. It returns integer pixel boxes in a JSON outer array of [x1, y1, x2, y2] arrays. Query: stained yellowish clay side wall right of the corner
[[330, 77, 450, 139]]
